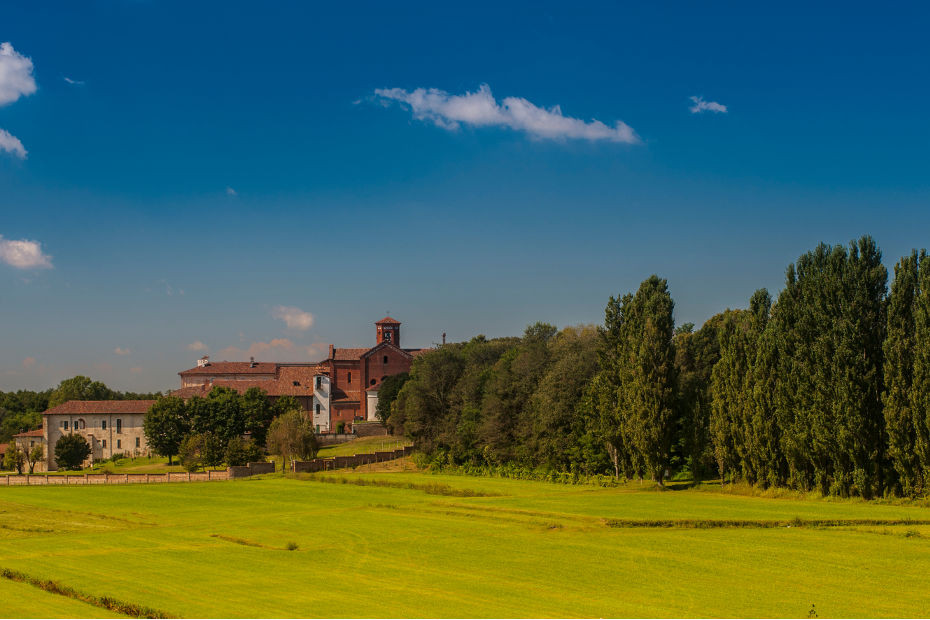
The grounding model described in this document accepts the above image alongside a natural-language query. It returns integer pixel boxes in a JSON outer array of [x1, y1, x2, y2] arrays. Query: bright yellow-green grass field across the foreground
[[0, 464, 930, 617]]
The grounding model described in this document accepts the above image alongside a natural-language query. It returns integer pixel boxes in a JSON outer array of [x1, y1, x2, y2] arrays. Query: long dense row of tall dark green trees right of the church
[[392, 237, 930, 497]]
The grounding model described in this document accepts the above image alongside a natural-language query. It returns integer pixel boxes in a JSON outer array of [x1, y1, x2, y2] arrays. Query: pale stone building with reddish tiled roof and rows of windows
[[40, 400, 155, 471]]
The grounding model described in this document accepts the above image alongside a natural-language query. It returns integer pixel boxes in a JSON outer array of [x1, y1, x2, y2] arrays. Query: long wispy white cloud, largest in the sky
[[375, 84, 640, 144]]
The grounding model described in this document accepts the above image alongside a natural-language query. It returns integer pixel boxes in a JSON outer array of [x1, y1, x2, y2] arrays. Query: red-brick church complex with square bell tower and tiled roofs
[[172, 316, 428, 433]]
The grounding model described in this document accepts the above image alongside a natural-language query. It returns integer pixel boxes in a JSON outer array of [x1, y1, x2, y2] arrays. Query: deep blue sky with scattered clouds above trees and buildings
[[0, 0, 930, 390]]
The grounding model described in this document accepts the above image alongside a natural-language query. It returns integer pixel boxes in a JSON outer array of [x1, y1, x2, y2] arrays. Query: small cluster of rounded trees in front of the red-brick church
[[143, 386, 316, 471]]
